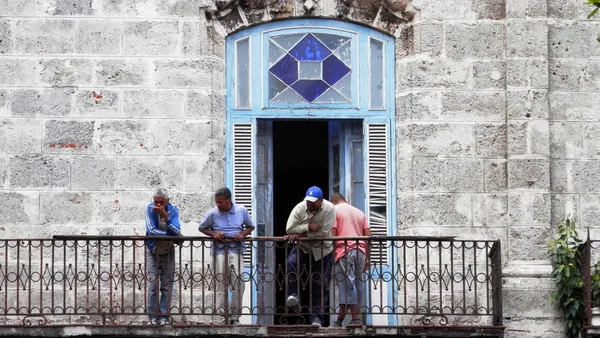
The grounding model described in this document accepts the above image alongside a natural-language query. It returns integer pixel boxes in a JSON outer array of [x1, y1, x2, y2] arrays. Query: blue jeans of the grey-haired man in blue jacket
[[146, 250, 175, 320]]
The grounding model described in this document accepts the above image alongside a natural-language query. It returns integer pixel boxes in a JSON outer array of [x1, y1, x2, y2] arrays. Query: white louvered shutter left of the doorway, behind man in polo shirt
[[233, 123, 253, 266]]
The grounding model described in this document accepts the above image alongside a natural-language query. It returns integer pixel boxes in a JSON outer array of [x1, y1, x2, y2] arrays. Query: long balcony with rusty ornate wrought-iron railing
[[0, 236, 504, 337]]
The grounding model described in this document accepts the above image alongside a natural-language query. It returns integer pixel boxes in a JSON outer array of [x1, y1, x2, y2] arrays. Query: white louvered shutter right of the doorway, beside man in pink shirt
[[367, 123, 389, 264]]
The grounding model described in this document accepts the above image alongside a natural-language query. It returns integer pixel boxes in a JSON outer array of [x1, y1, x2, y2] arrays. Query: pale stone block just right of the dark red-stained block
[[96, 120, 151, 155]]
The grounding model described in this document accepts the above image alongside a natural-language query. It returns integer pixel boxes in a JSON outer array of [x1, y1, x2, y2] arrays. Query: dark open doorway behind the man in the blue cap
[[272, 120, 329, 325]]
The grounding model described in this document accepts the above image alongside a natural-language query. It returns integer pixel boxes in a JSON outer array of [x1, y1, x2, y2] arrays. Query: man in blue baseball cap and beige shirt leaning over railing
[[285, 186, 335, 327]]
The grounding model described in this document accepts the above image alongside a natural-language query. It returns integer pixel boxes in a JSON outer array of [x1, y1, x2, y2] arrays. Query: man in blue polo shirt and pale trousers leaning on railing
[[199, 188, 254, 325]]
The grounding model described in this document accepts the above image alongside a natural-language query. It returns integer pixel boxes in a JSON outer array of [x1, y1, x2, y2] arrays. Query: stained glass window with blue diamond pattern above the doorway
[[268, 33, 352, 104]]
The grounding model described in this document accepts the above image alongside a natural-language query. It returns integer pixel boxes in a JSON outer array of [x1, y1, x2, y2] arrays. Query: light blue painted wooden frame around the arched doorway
[[225, 18, 398, 325]]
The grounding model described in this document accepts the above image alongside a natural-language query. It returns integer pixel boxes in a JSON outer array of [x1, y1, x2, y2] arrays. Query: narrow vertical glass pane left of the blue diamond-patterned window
[[235, 38, 250, 109]]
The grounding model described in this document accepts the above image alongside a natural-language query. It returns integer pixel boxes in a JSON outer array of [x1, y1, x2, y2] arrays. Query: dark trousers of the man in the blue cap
[[287, 247, 333, 321]]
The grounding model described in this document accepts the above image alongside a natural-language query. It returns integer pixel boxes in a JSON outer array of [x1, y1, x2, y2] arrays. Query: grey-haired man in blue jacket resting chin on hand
[[146, 188, 181, 325]]
